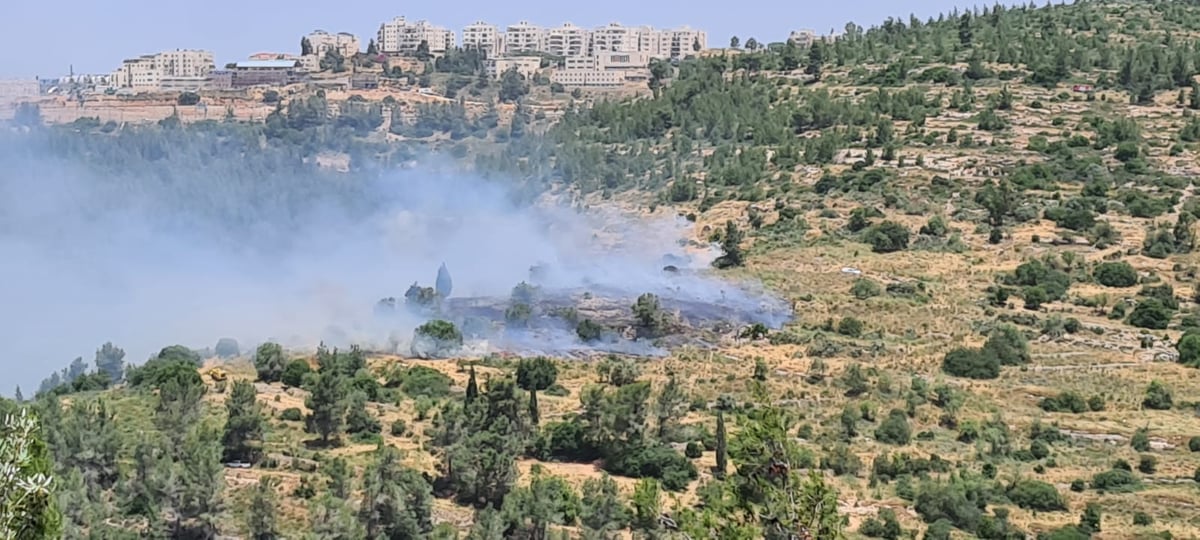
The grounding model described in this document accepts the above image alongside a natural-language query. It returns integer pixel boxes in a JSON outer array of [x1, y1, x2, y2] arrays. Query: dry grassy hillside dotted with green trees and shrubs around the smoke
[[7, 0, 1200, 539]]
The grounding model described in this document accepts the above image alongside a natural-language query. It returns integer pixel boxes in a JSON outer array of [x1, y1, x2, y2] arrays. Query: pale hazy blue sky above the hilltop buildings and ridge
[[0, 0, 1032, 78]]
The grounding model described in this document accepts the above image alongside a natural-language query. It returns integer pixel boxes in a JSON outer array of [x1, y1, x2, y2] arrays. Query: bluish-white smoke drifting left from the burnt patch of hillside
[[0, 130, 790, 395]]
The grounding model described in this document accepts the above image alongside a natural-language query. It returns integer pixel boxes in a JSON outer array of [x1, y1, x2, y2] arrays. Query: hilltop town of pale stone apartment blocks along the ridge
[[0, 17, 826, 124]]
